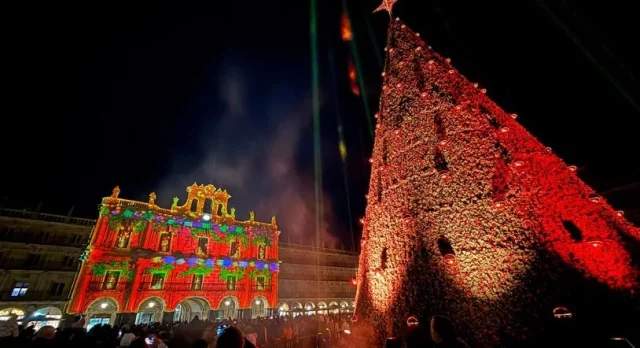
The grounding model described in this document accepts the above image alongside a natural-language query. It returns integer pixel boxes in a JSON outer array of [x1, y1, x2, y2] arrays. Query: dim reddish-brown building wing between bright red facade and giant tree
[[278, 243, 358, 315]]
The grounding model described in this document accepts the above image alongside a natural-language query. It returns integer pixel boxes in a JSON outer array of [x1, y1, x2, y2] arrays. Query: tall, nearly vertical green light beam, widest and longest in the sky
[[309, 0, 324, 292]]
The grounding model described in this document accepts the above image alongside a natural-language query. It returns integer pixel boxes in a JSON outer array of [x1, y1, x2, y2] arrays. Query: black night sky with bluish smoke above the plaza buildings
[[0, 0, 640, 248]]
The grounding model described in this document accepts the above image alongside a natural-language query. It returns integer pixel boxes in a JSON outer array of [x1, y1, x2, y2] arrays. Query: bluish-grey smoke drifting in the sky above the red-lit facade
[[157, 62, 342, 248]]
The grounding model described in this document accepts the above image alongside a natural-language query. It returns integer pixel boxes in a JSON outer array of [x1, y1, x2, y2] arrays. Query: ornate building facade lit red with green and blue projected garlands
[[68, 184, 280, 326]]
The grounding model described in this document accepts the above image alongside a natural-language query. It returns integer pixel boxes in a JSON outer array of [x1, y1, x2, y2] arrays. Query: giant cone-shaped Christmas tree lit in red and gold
[[356, 1, 640, 346]]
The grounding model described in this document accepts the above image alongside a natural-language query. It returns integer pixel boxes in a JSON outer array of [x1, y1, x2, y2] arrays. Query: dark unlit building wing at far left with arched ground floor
[[0, 209, 95, 328]]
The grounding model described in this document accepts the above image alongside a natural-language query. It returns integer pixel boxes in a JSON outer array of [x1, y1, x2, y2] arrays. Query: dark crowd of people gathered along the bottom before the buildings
[[0, 314, 370, 348]]
